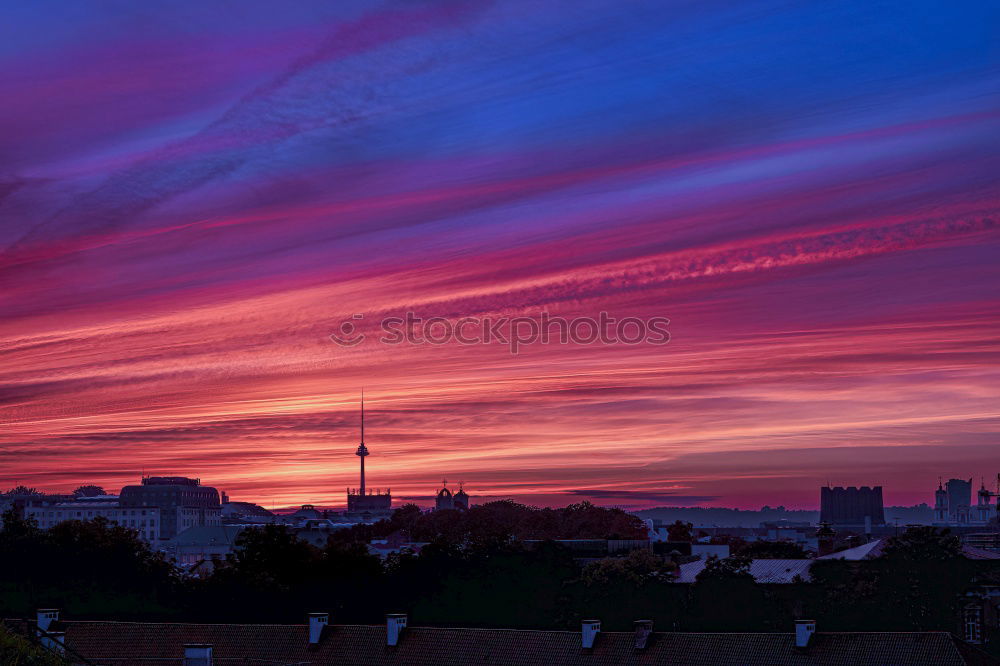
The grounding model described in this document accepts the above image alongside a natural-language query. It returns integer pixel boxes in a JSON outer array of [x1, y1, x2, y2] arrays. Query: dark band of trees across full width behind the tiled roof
[[0, 507, 1000, 644]]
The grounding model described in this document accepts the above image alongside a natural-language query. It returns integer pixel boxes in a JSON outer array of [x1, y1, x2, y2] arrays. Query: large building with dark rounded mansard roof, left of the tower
[[118, 476, 222, 539]]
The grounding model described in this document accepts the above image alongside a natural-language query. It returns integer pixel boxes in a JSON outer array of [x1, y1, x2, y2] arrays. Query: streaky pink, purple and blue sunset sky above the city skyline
[[0, 0, 1000, 508]]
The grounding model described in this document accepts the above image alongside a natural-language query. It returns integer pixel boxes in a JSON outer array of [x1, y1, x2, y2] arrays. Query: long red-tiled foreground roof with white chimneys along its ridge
[[7, 611, 1000, 666]]
